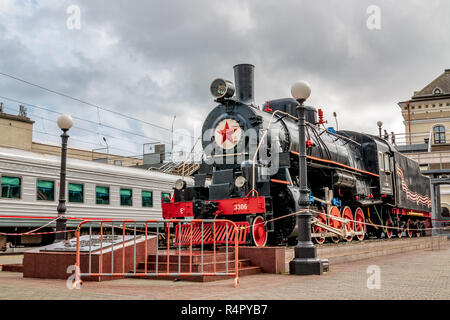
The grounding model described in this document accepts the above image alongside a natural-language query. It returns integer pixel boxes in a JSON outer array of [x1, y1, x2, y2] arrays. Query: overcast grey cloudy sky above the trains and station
[[0, 0, 450, 155]]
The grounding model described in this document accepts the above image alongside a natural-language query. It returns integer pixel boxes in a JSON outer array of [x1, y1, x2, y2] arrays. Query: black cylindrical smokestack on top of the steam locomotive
[[233, 64, 255, 104]]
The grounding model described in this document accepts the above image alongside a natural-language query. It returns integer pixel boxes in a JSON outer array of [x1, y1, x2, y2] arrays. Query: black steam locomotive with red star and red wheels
[[163, 64, 431, 246]]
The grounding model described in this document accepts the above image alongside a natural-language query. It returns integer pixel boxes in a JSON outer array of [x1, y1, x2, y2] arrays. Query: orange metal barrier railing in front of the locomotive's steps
[[75, 219, 239, 287]]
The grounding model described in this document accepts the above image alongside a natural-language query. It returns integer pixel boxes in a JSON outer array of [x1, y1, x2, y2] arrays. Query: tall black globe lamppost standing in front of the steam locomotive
[[289, 81, 328, 275]]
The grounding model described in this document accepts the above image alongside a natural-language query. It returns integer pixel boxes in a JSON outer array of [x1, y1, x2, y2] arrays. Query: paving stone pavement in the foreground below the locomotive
[[0, 245, 450, 300]]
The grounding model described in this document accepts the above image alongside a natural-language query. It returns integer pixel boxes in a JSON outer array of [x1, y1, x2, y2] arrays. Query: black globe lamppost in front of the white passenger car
[[55, 114, 73, 242]]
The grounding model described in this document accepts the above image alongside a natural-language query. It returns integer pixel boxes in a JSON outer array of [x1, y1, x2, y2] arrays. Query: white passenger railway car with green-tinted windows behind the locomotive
[[0, 147, 189, 246]]
